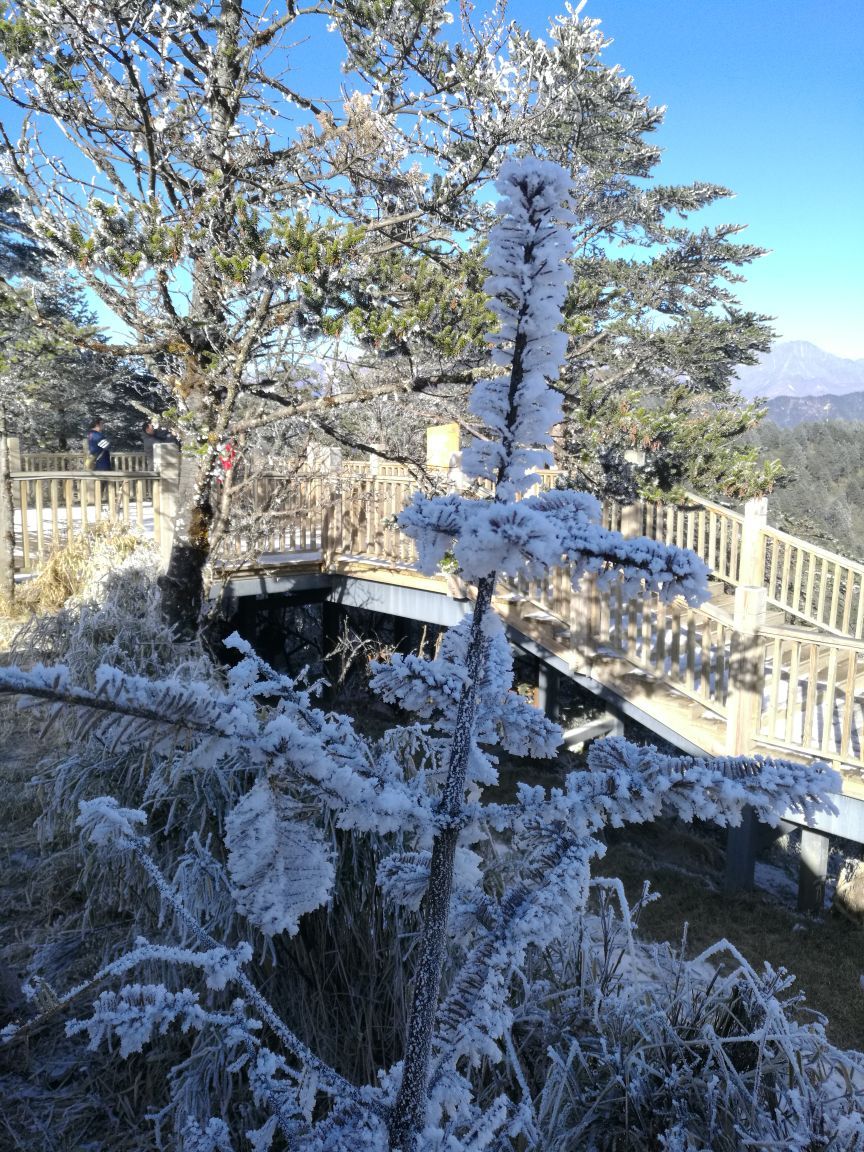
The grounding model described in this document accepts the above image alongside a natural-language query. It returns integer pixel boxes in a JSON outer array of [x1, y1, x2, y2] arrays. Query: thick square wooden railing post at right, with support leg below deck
[[726, 497, 768, 890]]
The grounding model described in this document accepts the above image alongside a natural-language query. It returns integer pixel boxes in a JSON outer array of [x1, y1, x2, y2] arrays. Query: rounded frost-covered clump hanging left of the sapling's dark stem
[[225, 780, 334, 935]]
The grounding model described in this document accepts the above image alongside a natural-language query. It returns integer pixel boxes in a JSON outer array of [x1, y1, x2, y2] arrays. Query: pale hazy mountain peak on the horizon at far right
[[737, 340, 864, 400]]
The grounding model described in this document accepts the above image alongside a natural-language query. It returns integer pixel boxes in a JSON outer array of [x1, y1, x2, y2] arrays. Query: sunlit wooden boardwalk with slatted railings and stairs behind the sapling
[[5, 444, 864, 797]]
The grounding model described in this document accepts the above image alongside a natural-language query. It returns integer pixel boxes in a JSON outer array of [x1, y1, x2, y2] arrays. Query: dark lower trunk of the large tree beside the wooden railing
[[159, 450, 214, 637]]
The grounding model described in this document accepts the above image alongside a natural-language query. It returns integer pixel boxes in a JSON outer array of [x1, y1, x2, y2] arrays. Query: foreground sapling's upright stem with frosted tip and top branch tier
[[378, 159, 707, 1152]]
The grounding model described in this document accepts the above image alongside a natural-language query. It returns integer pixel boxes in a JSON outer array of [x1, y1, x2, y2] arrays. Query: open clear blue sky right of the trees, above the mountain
[[509, 0, 864, 358]]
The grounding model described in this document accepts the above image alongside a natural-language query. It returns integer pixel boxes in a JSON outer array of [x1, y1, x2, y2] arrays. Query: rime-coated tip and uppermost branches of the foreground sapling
[[399, 159, 707, 604]]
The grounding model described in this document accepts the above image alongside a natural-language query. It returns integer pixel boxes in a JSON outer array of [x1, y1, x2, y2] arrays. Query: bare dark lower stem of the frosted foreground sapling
[[389, 573, 495, 1152]]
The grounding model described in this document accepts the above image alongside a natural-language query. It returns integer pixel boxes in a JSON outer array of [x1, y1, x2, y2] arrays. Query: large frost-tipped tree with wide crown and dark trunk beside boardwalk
[[0, 0, 766, 626]]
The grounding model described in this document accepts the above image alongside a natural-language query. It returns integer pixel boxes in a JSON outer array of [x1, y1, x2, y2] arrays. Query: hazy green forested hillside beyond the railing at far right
[[749, 420, 864, 560]]
